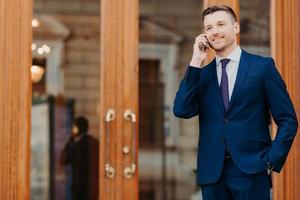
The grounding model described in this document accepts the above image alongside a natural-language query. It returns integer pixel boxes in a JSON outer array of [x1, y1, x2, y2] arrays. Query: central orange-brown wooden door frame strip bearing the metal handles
[[100, 0, 139, 200]]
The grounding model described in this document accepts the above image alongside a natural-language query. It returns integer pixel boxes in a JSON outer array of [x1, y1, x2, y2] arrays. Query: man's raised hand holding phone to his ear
[[190, 34, 210, 68]]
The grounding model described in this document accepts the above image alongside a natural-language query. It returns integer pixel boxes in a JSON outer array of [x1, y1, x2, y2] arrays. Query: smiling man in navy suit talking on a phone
[[173, 6, 298, 200]]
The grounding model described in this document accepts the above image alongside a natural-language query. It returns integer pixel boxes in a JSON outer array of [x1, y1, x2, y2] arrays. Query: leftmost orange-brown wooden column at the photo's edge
[[0, 0, 32, 200]]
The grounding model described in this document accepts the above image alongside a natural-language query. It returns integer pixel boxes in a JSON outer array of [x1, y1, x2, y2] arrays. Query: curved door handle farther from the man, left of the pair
[[105, 109, 116, 179]]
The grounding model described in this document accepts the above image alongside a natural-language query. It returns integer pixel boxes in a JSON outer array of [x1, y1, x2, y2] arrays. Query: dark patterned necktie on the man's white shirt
[[220, 58, 230, 111]]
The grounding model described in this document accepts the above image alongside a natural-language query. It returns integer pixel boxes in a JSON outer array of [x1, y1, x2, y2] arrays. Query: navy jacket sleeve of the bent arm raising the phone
[[173, 66, 201, 118]]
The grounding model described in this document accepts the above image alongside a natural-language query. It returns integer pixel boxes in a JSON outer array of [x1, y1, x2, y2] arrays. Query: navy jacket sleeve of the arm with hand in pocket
[[264, 59, 298, 172]]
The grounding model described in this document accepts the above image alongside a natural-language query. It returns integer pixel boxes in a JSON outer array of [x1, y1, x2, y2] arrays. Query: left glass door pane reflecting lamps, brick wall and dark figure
[[31, 0, 100, 200]]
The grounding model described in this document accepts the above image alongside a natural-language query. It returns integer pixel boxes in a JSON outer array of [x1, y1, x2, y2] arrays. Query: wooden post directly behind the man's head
[[203, 0, 240, 63]]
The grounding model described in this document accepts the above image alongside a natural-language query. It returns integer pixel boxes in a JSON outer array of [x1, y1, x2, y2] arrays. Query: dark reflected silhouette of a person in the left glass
[[61, 116, 99, 200]]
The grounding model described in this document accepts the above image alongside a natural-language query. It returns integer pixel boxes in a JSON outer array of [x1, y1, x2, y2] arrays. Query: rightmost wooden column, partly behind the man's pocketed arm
[[271, 0, 300, 200]]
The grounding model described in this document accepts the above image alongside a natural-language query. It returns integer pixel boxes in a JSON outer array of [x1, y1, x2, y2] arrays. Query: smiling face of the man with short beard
[[203, 11, 240, 51]]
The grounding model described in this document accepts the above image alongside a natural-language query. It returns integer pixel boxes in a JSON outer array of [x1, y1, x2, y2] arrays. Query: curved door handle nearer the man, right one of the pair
[[123, 109, 136, 178]]
